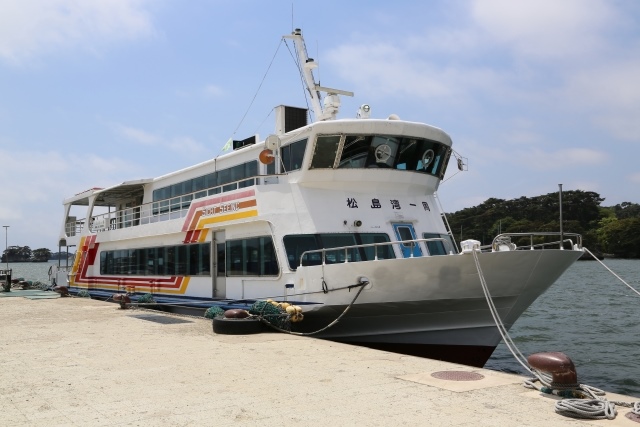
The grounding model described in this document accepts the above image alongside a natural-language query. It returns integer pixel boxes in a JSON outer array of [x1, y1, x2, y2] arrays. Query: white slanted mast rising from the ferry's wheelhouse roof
[[284, 28, 353, 121]]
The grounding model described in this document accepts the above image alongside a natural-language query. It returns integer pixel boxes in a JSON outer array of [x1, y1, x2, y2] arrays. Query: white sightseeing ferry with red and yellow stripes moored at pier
[[56, 30, 583, 366]]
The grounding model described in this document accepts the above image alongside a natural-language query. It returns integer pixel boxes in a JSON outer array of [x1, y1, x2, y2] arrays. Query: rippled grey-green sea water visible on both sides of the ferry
[[5, 259, 640, 397]]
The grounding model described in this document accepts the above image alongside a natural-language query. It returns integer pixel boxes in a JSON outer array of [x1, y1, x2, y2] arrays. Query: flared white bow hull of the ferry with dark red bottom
[[295, 250, 582, 366]]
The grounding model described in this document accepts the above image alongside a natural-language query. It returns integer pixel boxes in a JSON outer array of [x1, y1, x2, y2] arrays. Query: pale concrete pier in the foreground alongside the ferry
[[0, 297, 640, 427]]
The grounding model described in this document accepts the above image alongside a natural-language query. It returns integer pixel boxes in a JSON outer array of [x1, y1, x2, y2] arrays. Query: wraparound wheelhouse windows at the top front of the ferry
[[311, 135, 451, 178]]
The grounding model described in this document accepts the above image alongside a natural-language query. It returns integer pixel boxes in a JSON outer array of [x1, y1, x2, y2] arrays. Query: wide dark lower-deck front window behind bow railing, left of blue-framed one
[[283, 233, 395, 270]]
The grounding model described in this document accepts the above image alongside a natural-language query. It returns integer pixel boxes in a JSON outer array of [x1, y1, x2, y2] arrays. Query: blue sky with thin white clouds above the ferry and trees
[[0, 0, 640, 251]]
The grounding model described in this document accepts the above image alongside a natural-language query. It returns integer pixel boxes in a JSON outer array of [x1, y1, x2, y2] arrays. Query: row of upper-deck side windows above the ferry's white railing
[[153, 139, 307, 206]]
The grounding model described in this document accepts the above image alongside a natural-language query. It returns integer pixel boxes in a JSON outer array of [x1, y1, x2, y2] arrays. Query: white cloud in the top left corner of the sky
[[0, 0, 153, 63]]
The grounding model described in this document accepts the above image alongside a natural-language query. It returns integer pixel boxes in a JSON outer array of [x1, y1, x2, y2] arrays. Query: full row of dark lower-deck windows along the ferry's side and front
[[95, 233, 453, 277]]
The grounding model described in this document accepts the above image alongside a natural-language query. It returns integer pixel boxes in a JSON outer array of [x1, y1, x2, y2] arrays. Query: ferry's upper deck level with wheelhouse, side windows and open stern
[[61, 119, 451, 244]]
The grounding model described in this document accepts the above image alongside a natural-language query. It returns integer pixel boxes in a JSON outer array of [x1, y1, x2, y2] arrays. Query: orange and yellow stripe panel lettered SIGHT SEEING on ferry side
[[182, 189, 258, 231]]
